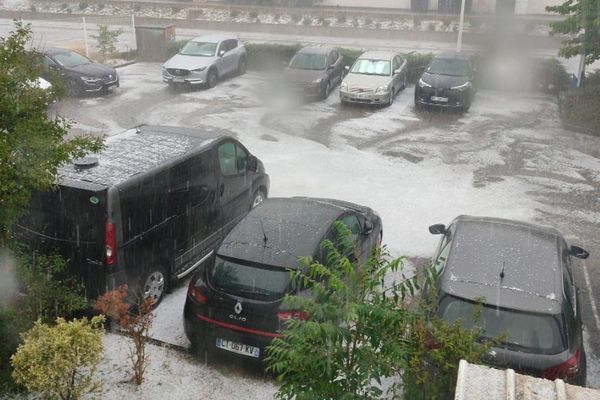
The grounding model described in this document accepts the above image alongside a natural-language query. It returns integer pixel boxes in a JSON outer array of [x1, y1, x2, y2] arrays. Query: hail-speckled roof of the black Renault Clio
[[217, 197, 365, 268]]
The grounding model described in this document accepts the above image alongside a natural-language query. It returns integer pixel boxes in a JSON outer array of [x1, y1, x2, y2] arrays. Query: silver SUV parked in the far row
[[162, 34, 247, 88]]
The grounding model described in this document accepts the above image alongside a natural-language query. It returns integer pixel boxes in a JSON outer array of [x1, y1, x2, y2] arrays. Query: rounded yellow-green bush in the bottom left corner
[[11, 316, 104, 400]]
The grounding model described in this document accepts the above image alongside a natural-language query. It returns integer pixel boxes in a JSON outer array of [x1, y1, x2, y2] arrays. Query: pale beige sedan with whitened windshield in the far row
[[340, 51, 408, 105]]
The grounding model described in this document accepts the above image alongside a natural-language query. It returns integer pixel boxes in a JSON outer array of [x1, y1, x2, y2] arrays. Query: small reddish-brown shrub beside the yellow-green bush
[[94, 285, 154, 385]]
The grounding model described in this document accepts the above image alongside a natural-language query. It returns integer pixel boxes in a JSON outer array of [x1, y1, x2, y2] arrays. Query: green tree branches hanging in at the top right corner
[[546, 0, 600, 65]]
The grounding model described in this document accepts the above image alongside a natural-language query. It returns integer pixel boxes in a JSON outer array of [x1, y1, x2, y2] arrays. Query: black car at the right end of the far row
[[415, 53, 477, 111]]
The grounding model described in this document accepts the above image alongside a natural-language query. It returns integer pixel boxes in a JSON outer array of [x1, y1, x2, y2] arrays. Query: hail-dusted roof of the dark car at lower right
[[440, 216, 566, 314]]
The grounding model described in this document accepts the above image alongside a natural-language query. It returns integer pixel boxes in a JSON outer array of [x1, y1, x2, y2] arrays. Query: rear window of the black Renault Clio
[[209, 256, 290, 300]]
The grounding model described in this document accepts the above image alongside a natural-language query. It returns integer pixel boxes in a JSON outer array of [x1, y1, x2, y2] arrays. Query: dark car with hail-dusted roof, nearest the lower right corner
[[429, 216, 588, 385]]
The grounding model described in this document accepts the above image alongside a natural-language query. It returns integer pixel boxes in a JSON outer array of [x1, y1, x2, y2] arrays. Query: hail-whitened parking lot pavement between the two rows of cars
[[53, 63, 600, 388]]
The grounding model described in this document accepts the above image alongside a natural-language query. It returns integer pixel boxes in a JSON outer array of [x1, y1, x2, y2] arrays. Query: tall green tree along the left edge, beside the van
[[0, 21, 102, 241]]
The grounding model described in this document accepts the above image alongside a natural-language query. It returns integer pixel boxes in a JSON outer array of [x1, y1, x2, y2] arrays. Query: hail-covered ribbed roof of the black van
[[58, 125, 226, 186]]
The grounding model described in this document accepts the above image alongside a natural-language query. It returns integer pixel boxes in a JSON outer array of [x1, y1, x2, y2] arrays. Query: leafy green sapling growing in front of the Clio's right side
[[266, 223, 489, 400]]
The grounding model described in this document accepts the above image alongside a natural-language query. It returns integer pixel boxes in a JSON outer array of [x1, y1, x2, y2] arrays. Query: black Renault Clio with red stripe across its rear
[[184, 198, 382, 360]]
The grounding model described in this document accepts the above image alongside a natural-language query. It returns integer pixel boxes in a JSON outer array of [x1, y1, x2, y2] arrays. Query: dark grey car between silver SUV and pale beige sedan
[[283, 46, 344, 99]]
